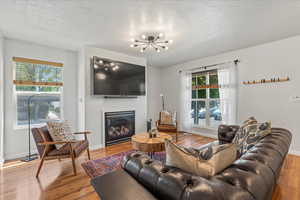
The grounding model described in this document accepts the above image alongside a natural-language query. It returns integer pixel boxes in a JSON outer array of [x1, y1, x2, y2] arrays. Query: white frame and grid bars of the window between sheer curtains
[[191, 70, 220, 130]]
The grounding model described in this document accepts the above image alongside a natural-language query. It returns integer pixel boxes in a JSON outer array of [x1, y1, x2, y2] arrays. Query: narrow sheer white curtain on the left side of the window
[[180, 71, 193, 132]]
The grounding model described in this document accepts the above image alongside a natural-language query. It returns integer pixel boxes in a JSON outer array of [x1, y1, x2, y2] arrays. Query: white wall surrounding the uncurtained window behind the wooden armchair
[[4, 39, 78, 159]]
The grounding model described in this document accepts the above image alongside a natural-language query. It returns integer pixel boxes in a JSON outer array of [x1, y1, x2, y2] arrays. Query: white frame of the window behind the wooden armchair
[[11, 61, 64, 130]]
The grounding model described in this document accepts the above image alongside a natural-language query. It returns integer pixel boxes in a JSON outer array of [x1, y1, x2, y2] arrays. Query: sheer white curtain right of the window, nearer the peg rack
[[218, 63, 237, 124]]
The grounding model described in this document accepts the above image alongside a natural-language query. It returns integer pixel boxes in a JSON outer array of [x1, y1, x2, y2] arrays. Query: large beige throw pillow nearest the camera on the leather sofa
[[165, 140, 237, 178]]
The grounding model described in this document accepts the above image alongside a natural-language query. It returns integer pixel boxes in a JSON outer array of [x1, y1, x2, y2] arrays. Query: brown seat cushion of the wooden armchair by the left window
[[48, 140, 89, 157]]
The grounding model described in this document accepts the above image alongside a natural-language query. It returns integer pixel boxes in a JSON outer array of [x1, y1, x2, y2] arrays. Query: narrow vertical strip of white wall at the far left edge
[[0, 32, 4, 167]]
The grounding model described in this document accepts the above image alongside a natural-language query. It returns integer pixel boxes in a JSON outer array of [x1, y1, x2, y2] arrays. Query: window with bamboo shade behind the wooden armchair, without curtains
[[13, 57, 63, 126]]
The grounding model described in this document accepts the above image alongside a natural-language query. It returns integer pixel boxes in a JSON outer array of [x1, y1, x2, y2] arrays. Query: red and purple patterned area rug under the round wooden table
[[81, 150, 166, 178]]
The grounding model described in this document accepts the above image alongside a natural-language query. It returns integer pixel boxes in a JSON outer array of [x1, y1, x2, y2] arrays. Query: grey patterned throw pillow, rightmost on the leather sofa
[[241, 122, 271, 155]]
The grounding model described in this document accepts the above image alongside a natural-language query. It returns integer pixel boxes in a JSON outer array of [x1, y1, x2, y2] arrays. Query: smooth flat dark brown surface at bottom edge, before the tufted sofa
[[91, 169, 156, 200]]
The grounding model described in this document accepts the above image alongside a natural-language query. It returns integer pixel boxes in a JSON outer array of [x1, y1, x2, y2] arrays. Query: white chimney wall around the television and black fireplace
[[78, 47, 148, 149]]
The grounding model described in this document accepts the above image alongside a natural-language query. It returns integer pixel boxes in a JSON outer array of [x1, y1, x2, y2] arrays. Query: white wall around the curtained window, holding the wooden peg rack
[[162, 36, 300, 153]]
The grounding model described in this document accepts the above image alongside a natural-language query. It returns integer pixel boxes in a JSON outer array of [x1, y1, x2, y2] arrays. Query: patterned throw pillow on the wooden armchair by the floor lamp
[[47, 121, 75, 149]]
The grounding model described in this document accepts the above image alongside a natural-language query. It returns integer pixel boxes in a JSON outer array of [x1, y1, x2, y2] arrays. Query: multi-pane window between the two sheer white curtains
[[191, 70, 222, 128]]
